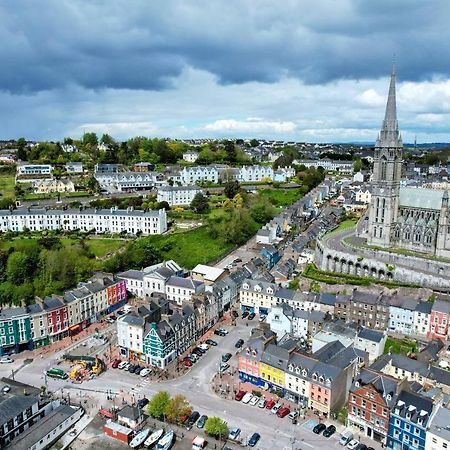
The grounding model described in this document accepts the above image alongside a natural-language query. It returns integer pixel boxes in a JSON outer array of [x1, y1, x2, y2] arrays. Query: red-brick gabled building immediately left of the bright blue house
[[347, 369, 406, 445]]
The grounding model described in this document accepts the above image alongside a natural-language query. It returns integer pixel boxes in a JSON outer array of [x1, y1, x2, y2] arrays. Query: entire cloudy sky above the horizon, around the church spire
[[0, 0, 450, 142]]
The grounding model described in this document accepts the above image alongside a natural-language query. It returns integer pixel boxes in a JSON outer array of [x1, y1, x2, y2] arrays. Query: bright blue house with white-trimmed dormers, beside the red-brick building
[[387, 391, 433, 450]]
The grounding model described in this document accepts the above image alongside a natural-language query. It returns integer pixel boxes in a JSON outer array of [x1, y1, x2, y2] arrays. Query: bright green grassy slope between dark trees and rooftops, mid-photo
[[146, 227, 233, 269]]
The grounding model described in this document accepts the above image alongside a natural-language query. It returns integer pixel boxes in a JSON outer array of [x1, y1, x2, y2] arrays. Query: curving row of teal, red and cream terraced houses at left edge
[[0, 273, 127, 355]]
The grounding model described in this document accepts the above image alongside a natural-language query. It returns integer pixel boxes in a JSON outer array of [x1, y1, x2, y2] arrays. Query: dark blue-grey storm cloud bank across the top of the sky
[[0, 0, 450, 93]]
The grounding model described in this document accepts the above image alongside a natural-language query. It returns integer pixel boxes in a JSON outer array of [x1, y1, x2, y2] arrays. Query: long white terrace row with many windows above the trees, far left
[[0, 208, 167, 236]]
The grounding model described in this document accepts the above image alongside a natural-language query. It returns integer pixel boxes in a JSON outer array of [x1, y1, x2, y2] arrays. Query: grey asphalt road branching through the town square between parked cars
[[0, 320, 382, 450]]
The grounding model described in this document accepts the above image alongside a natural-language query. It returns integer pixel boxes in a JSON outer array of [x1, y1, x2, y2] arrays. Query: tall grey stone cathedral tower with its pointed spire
[[367, 67, 403, 247]]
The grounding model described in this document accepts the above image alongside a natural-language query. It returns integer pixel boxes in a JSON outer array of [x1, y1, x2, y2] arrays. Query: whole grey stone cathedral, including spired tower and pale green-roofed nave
[[366, 66, 450, 258]]
